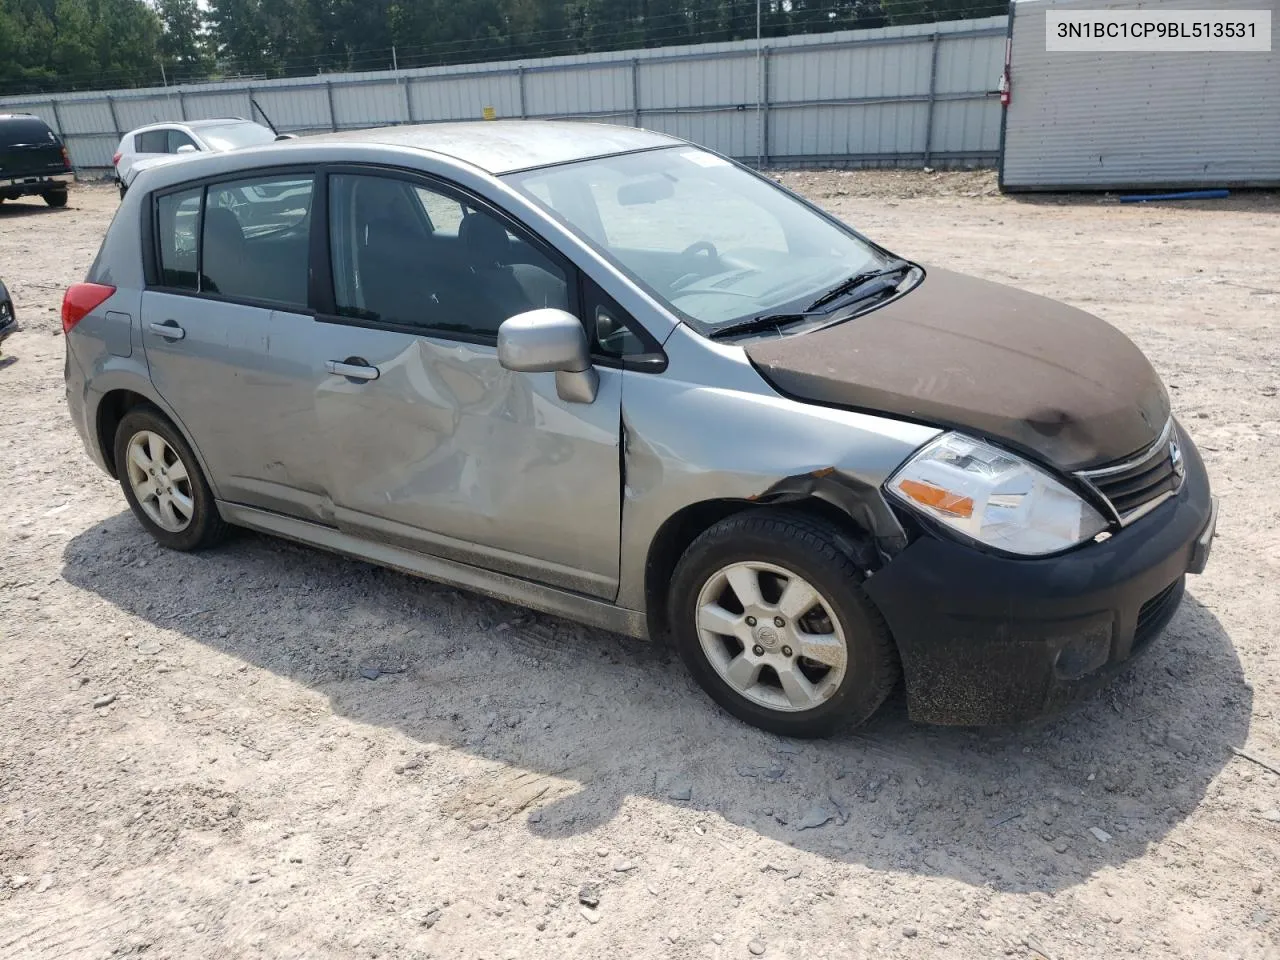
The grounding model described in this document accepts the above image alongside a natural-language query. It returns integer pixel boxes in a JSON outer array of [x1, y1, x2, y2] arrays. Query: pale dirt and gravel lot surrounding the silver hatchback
[[0, 173, 1280, 960]]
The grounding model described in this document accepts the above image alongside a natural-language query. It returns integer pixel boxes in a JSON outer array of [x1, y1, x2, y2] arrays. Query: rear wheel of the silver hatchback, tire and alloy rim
[[113, 404, 230, 550]]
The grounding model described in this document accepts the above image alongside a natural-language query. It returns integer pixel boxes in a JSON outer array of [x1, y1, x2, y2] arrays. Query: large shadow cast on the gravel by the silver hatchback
[[63, 512, 1252, 891]]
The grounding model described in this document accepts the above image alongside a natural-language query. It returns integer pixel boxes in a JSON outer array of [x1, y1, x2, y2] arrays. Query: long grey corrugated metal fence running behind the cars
[[0, 17, 1007, 170]]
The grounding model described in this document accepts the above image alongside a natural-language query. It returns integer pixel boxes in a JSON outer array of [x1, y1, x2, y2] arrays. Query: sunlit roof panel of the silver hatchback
[[302, 120, 682, 174]]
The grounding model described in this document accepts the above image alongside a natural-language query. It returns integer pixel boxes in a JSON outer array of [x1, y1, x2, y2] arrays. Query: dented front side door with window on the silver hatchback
[[316, 168, 622, 598]]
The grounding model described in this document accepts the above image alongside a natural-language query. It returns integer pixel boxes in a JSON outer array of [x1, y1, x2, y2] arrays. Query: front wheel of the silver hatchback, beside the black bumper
[[667, 509, 900, 737]]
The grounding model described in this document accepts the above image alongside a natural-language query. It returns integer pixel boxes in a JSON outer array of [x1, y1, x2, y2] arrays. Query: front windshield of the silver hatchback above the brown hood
[[506, 146, 890, 335]]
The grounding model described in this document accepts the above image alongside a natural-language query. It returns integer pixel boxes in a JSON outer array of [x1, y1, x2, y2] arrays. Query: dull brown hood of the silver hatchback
[[746, 268, 1169, 470]]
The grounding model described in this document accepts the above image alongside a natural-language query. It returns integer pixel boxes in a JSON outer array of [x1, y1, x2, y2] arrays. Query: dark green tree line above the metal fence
[[0, 0, 1009, 93]]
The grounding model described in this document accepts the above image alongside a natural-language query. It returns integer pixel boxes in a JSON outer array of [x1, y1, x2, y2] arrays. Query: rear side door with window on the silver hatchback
[[142, 172, 332, 522]]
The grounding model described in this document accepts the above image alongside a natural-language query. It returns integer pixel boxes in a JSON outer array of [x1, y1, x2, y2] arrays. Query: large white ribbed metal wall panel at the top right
[[1001, 0, 1280, 191]]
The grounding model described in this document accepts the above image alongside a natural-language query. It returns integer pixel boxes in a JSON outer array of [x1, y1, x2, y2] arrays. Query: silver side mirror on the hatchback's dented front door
[[498, 308, 600, 403]]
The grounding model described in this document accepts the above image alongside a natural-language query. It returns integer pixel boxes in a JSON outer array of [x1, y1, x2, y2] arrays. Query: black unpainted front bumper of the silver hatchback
[[864, 424, 1216, 724]]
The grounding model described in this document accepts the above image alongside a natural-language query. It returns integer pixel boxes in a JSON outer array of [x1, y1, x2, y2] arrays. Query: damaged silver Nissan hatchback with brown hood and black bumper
[[63, 122, 1216, 736]]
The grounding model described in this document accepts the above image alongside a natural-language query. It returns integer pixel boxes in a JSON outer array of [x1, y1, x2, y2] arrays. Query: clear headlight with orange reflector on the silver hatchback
[[884, 434, 1107, 557]]
